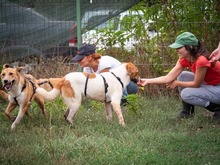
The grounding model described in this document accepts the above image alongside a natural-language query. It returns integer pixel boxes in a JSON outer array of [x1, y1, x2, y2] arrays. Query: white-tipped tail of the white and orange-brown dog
[[36, 78, 65, 101]]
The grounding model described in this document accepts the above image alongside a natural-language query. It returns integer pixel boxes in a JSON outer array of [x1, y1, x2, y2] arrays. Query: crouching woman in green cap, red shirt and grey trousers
[[139, 32, 220, 120]]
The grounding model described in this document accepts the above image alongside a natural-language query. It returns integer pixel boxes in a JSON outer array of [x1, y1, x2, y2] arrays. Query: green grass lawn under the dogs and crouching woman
[[0, 97, 220, 165]]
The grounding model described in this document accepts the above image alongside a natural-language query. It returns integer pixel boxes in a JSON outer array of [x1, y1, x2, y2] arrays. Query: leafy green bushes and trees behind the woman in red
[[98, 0, 220, 76]]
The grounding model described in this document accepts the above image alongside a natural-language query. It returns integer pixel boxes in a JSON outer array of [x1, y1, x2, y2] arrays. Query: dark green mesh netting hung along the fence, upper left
[[0, 0, 140, 63]]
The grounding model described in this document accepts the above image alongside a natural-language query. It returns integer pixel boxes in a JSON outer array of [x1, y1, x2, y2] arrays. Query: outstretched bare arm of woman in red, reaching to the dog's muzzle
[[138, 61, 184, 86]]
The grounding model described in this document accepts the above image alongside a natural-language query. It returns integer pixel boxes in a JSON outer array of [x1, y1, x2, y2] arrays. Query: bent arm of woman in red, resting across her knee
[[167, 67, 208, 89]]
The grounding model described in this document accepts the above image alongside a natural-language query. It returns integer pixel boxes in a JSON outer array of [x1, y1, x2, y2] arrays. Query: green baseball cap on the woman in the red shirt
[[169, 32, 198, 49]]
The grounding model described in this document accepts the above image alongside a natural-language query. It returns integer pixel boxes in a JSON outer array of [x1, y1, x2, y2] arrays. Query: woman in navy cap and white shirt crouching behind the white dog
[[73, 44, 138, 105]]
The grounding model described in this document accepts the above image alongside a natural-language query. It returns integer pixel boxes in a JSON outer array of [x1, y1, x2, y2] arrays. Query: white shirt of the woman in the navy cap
[[83, 56, 121, 73]]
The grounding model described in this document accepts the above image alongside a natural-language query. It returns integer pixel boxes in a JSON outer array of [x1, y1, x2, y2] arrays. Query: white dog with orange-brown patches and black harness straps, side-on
[[36, 63, 140, 126]]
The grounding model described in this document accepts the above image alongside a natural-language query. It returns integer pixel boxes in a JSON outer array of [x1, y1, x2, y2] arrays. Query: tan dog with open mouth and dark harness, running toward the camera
[[1, 64, 46, 129]]
